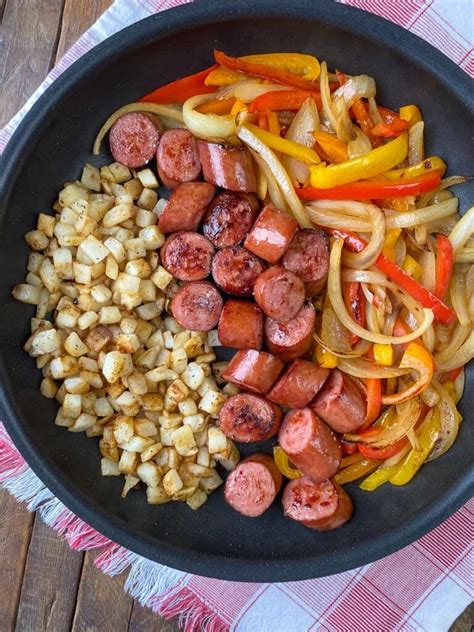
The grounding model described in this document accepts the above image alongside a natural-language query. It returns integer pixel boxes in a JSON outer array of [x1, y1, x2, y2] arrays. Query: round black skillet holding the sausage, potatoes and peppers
[[0, 0, 474, 581]]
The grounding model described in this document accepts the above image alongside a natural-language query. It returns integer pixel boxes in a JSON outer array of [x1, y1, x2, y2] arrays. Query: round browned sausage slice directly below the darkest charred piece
[[212, 246, 265, 296]]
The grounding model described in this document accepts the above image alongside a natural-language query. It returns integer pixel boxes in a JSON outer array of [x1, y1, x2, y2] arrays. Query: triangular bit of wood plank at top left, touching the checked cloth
[[56, 0, 113, 61]]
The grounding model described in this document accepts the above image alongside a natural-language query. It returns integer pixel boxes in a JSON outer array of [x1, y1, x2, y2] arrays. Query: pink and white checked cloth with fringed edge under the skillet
[[0, 0, 474, 632]]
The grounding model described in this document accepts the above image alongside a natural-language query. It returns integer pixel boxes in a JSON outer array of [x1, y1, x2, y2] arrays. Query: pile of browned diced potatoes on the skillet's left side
[[13, 163, 239, 509]]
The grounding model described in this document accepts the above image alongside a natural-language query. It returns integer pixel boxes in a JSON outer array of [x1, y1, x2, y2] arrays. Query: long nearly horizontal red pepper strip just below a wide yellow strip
[[296, 169, 442, 200]]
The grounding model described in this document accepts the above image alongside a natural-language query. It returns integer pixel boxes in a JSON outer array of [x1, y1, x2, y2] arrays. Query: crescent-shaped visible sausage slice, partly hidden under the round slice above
[[265, 303, 316, 361]]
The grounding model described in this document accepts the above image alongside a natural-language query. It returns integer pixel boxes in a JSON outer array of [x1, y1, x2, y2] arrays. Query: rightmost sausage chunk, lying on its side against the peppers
[[311, 369, 366, 433]]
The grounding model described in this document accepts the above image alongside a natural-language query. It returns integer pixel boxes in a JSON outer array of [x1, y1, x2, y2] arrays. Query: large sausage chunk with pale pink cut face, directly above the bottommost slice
[[278, 408, 341, 483]]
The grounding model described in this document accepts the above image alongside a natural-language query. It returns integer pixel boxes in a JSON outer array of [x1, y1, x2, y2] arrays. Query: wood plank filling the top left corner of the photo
[[0, 0, 64, 126]]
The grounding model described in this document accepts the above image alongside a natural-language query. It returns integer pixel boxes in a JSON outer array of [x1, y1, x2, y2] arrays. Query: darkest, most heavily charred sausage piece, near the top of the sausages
[[202, 191, 258, 248]]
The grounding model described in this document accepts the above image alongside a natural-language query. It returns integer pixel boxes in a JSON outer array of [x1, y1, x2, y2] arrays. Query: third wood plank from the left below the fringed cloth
[[71, 553, 133, 632]]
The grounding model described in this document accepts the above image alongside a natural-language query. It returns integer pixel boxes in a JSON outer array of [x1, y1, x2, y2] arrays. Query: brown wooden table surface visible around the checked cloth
[[0, 0, 472, 632]]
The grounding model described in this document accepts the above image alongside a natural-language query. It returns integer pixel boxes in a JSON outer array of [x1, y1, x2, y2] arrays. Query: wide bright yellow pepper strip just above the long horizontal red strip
[[309, 132, 408, 189]]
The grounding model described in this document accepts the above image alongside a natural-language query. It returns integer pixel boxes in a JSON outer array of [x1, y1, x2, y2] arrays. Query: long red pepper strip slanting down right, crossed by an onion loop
[[325, 228, 456, 325]]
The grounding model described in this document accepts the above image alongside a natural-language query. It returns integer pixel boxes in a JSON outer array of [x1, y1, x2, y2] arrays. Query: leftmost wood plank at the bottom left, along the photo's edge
[[0, 489, 33, 632]]
